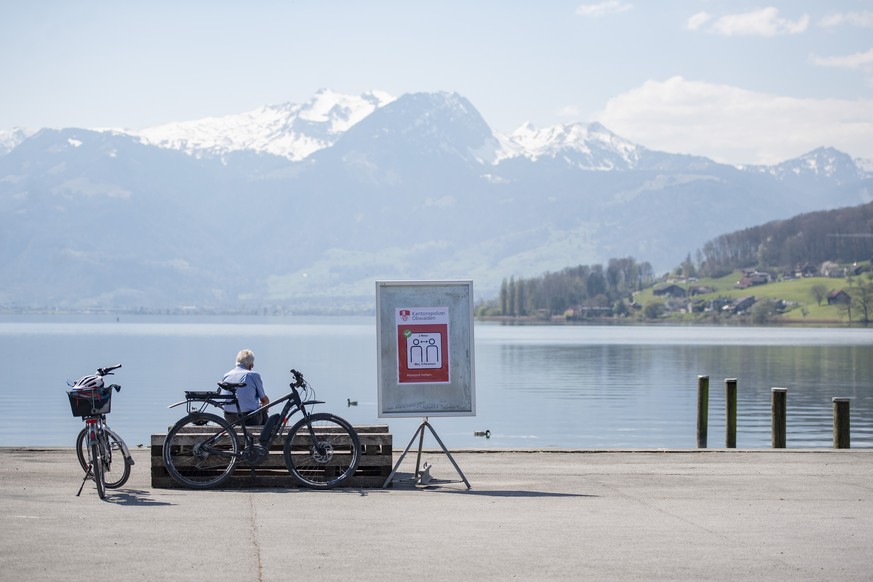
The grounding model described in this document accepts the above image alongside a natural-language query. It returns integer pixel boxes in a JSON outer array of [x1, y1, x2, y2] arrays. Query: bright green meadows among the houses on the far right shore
[[636, 271, 848, 323]]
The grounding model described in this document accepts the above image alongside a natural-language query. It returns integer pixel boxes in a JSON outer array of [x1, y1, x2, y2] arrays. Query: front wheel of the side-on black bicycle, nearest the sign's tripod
[[284, 412, 361, 489]]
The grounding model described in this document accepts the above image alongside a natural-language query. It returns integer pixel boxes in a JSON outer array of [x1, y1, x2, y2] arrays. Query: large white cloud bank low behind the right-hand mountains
[[595, 77, 873, 165]]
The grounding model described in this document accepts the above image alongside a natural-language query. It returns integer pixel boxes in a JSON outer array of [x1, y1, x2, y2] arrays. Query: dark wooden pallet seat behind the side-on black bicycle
[[151, 425, 393, 489]]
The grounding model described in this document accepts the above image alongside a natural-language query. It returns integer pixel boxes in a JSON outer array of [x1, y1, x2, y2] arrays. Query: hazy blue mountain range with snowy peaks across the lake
[[0, 90, 873, 312]]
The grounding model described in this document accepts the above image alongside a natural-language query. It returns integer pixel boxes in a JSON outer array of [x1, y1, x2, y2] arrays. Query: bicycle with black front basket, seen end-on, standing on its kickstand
[[67, 364, 134, 499]]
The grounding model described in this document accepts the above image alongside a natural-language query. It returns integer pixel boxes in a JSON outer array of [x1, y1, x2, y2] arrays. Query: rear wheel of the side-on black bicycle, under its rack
[[163, 412, 239, 489]]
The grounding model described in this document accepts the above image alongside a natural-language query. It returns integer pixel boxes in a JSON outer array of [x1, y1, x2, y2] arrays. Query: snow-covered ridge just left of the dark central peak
[[134, 89, 394, 161]]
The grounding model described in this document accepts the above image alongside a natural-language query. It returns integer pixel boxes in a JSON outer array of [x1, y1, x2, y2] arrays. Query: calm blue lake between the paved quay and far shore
[[0, 315, 873, 450]]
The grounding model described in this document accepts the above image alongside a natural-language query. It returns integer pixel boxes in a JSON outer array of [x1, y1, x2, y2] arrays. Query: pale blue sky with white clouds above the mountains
[[0, 0, 873, 164]]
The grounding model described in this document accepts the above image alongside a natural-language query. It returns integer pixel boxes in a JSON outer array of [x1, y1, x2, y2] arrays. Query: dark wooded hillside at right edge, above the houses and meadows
[[685, 202, 873, 277]]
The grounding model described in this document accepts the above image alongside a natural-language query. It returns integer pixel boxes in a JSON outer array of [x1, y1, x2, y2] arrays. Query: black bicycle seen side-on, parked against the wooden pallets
[[163, 370, 361, 489]]
